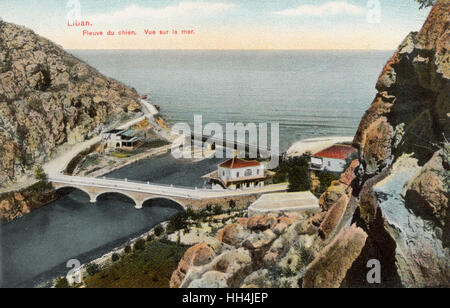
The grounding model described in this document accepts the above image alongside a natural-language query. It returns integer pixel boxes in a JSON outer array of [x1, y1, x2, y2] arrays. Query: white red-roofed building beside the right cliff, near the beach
[[310, 144, 358, 173]]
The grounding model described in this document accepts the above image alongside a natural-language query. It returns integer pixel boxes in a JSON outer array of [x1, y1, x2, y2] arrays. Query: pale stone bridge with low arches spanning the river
[[49, 175, 287, 209]]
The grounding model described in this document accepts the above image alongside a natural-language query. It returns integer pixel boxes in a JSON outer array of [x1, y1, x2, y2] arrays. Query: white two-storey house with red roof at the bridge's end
[[203, 158, 266, 190]]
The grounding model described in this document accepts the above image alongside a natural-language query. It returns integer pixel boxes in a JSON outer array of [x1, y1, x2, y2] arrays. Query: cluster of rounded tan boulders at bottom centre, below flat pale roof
[[170, 215, 321, 288]]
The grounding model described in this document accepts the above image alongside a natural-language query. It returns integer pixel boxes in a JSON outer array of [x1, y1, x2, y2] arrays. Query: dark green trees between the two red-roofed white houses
[[273, 154, 311, 192]]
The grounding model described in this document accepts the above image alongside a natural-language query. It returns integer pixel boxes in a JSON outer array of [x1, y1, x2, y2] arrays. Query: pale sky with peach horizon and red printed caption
[[0, 0, 429, 50]]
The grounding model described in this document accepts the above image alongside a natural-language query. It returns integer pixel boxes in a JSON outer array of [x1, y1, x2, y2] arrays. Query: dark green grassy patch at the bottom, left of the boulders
[[86, 240, 188, 288]]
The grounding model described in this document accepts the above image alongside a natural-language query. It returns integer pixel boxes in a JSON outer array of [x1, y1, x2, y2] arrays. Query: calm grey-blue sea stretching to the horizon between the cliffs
[[70, 50, 392, 151]]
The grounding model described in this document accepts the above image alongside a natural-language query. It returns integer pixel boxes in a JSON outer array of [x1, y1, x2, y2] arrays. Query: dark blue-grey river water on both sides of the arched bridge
[[0, 154, 218, 287]]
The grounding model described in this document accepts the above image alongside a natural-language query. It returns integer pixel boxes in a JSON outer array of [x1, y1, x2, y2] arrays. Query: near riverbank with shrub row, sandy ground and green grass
[[51, 207, 246, 288]]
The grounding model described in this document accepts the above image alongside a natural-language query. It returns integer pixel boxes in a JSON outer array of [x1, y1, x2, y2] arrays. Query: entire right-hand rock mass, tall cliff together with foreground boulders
[[171, 0, 450, 287]]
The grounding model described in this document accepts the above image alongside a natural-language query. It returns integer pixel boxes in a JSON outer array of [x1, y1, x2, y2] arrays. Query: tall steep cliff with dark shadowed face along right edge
[[345, 0, 450, 287]]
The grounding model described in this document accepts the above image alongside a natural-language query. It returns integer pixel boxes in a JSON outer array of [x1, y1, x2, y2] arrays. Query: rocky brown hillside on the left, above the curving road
[[0, 21, 139, 188]]
